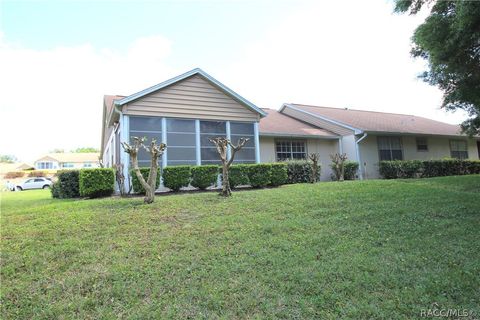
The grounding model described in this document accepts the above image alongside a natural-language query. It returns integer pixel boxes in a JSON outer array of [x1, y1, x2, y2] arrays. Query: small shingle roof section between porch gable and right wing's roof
[[259, 108, 338, 137]]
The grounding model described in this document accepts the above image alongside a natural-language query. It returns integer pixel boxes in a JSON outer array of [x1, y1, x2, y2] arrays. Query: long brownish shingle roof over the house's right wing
[[287, 103, 461, 136]]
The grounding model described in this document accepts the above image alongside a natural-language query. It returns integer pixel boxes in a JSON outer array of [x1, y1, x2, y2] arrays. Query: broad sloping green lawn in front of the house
[[0, 176, 480, 319]]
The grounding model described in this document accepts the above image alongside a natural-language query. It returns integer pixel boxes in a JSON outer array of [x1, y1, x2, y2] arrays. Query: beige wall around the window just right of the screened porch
[[260, 136, 338, 181]]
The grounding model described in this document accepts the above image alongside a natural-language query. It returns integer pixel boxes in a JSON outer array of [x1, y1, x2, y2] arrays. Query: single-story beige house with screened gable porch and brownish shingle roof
[[101, 69, 480, 188]]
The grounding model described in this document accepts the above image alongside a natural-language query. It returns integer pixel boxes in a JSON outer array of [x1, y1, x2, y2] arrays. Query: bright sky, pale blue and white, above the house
[[0, 0, 465, 161]]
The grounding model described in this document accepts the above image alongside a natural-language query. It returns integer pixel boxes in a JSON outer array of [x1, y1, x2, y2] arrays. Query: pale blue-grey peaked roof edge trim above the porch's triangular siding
[[114, 68, 266, 117]]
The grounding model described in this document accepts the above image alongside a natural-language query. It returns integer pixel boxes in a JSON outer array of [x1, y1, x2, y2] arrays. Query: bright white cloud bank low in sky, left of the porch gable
[[0, 35, 173, 161]]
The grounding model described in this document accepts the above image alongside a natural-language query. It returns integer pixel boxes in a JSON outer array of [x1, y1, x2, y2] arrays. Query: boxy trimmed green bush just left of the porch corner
[[79, 168, 115, 198]]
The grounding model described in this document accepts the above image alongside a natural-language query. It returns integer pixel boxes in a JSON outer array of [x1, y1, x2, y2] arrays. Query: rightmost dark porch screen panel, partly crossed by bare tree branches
[[230, 122, 255, 163]]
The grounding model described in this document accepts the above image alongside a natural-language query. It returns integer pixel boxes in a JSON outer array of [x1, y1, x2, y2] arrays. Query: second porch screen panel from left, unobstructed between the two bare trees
[[167, 119, 197, 166]]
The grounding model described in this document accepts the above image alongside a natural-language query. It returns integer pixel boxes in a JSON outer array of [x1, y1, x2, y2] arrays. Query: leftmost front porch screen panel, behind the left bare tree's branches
[[129, 116, 162, 167]]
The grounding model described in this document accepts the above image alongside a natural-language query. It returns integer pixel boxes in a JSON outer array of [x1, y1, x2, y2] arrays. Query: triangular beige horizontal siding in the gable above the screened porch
[[124, 75, 260, 122]]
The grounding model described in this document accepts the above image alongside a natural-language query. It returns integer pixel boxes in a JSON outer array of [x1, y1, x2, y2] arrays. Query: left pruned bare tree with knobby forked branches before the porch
[[122, 137, 167, 203]]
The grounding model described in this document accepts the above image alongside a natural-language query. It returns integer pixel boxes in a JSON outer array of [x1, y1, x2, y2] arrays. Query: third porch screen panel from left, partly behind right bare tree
[[200, 121, 227, 164]]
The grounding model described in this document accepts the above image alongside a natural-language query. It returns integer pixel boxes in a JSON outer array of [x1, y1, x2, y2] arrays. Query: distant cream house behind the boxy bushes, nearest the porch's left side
[[34, 152, 100, 170]]
